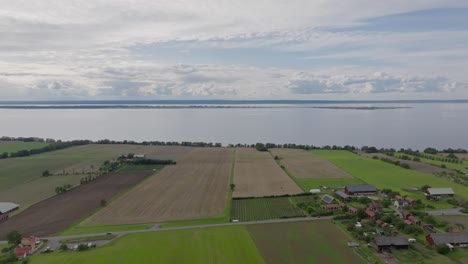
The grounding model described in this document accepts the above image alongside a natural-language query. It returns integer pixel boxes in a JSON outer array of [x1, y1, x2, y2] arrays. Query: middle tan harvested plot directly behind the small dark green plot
[[233, 148, 302, 197]]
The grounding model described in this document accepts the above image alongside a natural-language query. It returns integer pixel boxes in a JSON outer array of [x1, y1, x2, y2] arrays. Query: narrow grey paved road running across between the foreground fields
[[33, 216, 333, 249]]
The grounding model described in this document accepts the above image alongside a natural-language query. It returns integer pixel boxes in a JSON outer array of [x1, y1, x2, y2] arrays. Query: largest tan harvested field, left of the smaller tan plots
[[83, 148, 233, 225]]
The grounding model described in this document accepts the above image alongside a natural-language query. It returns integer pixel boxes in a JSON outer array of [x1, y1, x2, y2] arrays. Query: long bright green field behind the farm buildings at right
[[313, 150, 468, 208]]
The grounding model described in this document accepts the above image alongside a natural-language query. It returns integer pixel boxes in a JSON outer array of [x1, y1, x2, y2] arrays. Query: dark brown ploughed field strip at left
[[0, 172, 152, 239]]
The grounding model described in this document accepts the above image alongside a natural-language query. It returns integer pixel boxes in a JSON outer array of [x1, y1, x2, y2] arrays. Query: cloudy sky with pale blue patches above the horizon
[[0, 0, 468, 101]]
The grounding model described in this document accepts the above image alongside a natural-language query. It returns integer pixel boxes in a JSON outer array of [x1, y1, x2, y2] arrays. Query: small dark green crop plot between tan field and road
[[231, 197, 306, 221]]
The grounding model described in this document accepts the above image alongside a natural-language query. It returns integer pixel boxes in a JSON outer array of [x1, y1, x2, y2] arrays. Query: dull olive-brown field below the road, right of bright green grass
[[247, 221, 365, 264]]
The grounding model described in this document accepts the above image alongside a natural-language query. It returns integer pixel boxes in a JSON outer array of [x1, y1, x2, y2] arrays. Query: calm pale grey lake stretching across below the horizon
[[0, 103, 468, 149]]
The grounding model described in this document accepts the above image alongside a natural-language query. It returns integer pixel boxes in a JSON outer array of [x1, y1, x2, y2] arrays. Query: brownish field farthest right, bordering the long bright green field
[[270, 148, 353, 178]]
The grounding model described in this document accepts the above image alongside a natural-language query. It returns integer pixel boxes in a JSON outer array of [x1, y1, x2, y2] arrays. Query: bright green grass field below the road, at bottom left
[[31, 226, 264, 264]]
